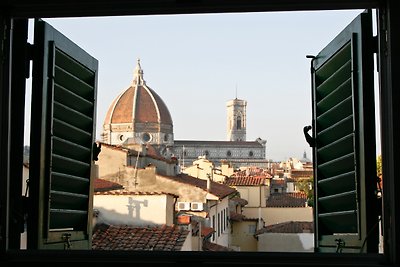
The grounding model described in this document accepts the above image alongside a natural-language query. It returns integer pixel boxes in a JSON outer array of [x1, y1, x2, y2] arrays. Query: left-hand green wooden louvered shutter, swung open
[[28, 20, 98, 249]]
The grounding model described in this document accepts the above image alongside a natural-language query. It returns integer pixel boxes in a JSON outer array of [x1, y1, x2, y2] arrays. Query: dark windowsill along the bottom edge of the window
[[1, 250, 389, 266]]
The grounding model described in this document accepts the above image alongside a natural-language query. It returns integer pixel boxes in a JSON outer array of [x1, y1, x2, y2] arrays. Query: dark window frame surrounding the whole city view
[[0, 0, 400, 266]]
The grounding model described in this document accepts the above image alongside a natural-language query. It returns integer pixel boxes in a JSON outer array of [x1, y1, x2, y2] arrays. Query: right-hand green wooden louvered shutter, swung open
[[312, 11, 379, 253]]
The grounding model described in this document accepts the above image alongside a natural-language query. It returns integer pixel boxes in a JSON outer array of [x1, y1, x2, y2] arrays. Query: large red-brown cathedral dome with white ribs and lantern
[[103, 60, 173, 148]]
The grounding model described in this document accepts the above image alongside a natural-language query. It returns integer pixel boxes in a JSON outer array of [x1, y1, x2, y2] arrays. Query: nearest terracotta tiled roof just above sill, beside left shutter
[[92, 224, 189, 251]]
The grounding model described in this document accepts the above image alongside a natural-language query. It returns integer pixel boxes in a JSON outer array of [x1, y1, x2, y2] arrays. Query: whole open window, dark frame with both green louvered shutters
[[0, 0, 400, 266]]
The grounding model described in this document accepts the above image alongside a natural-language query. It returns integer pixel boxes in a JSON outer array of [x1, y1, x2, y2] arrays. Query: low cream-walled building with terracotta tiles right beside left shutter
[[92, 179, 194, 251]]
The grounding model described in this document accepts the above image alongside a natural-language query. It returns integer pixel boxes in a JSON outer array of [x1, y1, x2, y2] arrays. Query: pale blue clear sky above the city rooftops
[[25, 10, 378, 161]]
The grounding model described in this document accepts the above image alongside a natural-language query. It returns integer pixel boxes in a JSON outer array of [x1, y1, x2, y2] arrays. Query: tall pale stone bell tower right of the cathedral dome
[[226, 98, 247, 141]]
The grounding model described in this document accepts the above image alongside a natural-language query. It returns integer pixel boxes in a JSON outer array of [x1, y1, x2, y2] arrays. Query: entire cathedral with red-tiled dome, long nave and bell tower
[[102, 60, 268, 167]]
